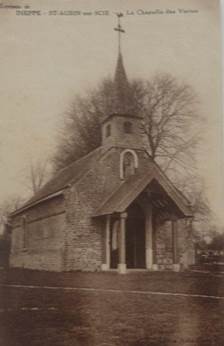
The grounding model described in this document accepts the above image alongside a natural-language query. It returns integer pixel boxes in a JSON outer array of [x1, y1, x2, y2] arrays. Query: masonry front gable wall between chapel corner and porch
[[62, 150, 121, 271]]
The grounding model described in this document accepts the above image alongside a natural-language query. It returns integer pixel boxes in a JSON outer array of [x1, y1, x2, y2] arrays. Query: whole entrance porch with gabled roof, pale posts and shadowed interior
[[94, 168, 192, 273]]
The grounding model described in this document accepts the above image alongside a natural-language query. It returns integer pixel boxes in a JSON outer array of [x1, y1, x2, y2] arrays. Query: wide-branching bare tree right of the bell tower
[[142, 74, 200, 174]]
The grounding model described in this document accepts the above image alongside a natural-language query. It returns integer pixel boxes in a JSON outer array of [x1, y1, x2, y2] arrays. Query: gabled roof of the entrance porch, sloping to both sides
[[93, 165, 192, 217]]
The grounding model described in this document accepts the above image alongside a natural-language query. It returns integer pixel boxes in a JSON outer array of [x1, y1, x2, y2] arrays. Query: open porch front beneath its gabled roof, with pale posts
[[102, 202, 180, 274]]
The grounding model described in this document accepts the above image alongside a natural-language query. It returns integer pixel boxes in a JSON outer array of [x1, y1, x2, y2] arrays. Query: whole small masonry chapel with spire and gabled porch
[[10, 21, 193, 274]]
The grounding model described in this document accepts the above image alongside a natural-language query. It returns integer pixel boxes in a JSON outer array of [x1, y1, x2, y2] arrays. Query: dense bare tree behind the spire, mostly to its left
[[53, 78, 144, 170]]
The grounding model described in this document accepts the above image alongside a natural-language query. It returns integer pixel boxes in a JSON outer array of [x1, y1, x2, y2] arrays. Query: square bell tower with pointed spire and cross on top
[[101, 13, 146, 149]]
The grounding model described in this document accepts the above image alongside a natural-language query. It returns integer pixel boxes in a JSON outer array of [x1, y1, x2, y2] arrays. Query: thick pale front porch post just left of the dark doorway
[[118, 213, 127, 274]]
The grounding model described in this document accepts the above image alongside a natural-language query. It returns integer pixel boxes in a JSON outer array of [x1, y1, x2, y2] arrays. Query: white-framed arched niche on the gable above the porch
[[120, 149, 138, 179]]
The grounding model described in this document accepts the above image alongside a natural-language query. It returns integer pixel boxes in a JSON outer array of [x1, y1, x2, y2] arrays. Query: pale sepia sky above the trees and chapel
[[0, 0, 224, 224]]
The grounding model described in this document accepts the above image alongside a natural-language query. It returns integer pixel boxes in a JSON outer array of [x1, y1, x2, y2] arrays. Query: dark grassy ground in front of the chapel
[[0, 273, 224, 346]]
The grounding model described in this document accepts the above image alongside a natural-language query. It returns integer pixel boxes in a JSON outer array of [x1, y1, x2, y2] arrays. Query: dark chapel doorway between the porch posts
[[126, 204, 146, 269]]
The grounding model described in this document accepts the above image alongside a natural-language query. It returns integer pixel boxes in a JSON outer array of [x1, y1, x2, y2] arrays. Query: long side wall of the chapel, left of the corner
[[10, 197, 66, 271]]
